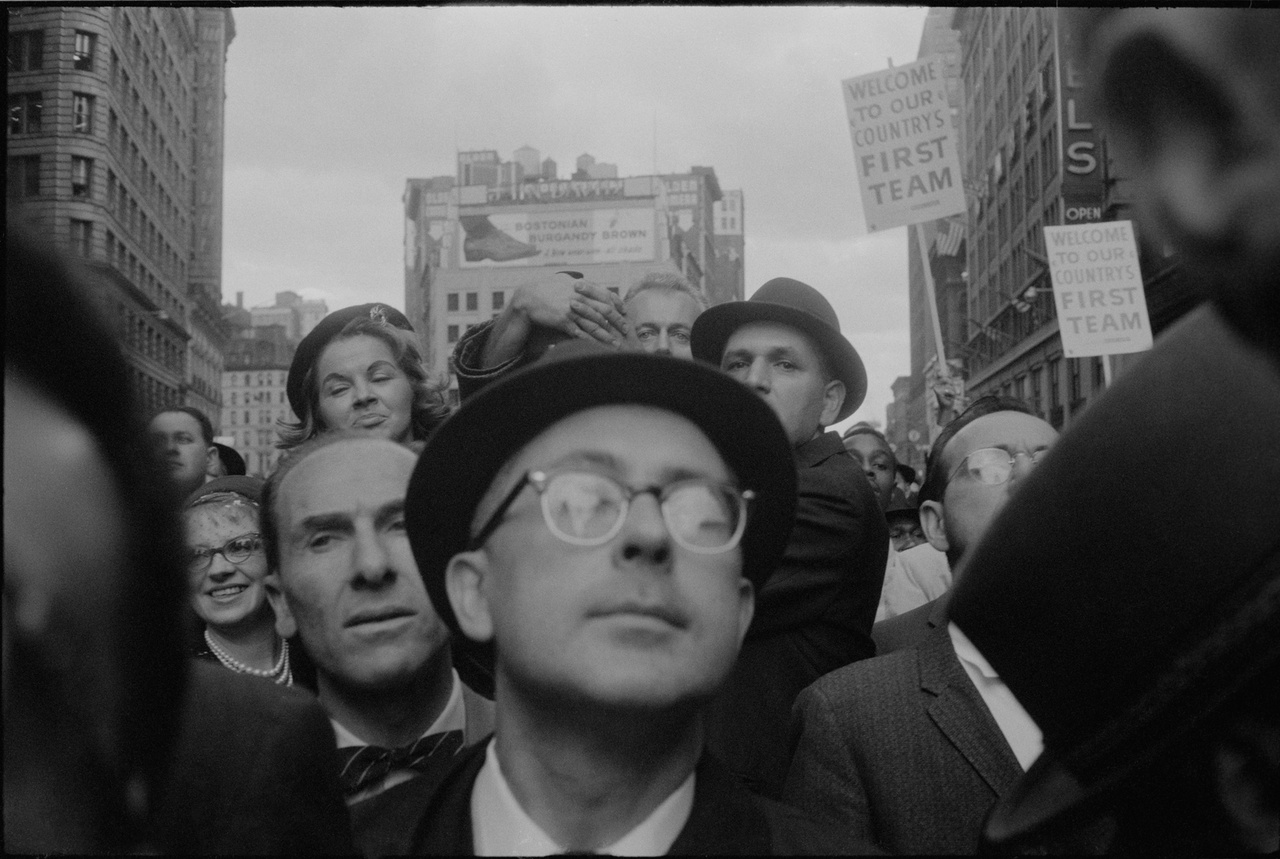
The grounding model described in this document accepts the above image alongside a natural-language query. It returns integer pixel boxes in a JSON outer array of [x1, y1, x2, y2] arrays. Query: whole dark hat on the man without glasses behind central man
[[692, 278, 867, 421]]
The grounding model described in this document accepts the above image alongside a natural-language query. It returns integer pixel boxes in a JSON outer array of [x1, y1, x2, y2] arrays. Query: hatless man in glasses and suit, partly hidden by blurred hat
[[785, 397, 1057, 854]]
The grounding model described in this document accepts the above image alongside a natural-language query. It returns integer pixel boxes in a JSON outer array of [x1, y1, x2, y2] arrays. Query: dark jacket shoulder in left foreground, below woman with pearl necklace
[[152, 659, 355, 855]]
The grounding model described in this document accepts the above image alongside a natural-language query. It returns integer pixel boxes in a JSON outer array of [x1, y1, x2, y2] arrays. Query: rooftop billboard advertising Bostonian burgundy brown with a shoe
[[458, 207, 658, 269]]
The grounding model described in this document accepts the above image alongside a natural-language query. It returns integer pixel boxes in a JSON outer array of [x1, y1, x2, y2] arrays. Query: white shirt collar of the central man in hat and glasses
[[471, 740, 694, 856]]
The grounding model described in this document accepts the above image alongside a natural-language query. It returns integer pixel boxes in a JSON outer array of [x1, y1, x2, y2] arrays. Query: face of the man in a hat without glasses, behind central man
[[721, 323, 845, 447]]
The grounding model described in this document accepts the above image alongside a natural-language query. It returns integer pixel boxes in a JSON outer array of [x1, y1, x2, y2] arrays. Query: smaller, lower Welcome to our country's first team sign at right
[[1044, 220, 1151, 358]]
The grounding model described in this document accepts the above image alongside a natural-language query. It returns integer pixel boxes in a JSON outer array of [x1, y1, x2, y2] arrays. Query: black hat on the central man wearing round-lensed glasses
[[404, 341, 796, 698]]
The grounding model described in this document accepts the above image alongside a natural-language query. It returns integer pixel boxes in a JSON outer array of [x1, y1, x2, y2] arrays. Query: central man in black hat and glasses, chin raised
[[406, 343, 846, 855]]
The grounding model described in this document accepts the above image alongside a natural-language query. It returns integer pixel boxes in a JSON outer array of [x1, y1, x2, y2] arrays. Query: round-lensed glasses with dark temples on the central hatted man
[[468, 471, 755, 554]]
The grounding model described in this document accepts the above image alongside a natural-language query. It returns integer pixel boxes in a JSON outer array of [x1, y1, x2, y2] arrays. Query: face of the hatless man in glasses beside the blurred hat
[[920, 412, 1057, 567]]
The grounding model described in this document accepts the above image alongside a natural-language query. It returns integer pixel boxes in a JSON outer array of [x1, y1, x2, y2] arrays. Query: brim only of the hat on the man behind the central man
[[691, 301, 867, 422]]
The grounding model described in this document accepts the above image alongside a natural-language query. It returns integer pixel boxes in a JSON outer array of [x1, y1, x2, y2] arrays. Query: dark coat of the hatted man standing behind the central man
[[708, 433, 888, 799]]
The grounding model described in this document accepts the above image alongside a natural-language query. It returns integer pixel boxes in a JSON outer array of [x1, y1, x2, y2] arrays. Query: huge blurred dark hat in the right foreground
[[950, 307, 1280, 850]]
